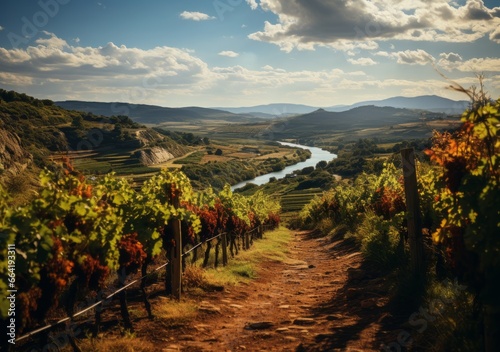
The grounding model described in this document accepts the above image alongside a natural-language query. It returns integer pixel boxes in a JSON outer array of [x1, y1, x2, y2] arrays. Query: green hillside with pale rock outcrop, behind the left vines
[[0, 90, 190, 190]]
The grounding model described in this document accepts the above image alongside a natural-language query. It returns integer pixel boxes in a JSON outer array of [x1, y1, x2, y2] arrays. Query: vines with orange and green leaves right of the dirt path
[[300, 87, 500, 351]]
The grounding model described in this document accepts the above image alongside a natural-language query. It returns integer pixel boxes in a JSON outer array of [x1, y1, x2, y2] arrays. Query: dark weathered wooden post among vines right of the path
[[401, 148, 425, 277]]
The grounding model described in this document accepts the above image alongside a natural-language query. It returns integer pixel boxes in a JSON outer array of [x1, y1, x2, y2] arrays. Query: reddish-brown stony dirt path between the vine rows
[[147, 232, 394, 351]]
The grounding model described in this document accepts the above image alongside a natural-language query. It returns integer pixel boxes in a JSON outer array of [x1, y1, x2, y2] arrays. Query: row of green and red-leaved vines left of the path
[[0, 161, 280, 350]]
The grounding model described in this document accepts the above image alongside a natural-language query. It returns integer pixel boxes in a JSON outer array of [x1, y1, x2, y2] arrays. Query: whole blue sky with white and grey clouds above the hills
[[0, 0, 500, 107]]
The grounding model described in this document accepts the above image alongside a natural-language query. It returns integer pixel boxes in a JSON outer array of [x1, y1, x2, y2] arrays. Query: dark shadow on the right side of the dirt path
[[296, 234, 412, 352]]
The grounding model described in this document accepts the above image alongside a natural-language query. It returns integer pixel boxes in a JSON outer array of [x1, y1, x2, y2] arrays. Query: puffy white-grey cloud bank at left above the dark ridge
[[0, 33, 215, 101]]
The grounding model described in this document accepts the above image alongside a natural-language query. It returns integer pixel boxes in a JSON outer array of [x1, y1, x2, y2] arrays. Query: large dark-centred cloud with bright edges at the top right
[[249, 0, 500, 52]]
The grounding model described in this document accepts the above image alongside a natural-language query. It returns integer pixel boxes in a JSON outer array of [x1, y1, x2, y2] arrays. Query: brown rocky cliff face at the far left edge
[[0, 129, 33, 175]]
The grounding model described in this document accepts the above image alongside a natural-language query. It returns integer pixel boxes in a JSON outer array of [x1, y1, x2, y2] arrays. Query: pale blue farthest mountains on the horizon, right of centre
[[216, 95, 468, 118]]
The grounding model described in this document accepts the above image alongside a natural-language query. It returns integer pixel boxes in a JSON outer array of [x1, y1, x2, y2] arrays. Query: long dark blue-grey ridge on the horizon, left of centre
[[55, 100, 262, 124]]
